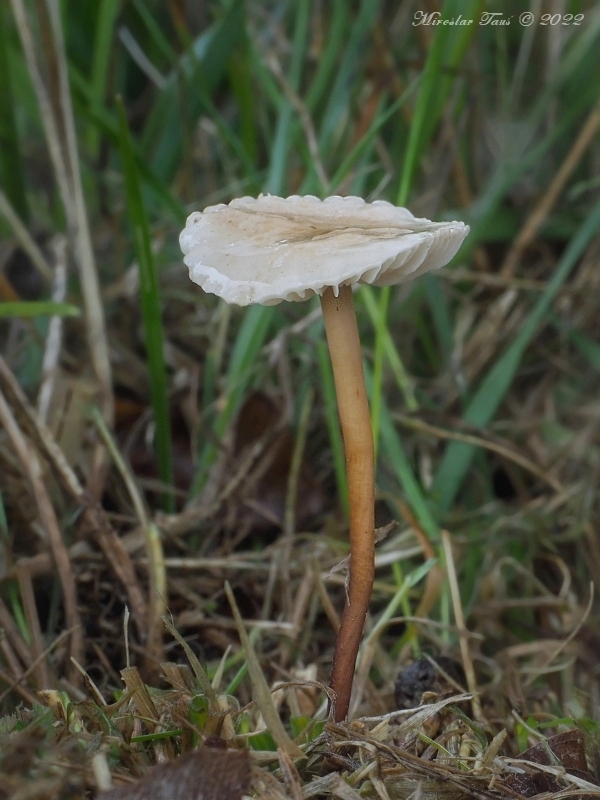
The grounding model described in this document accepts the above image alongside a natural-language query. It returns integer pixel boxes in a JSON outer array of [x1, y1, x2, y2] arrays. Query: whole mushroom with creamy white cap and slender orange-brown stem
[[179, 195, 469, 721]]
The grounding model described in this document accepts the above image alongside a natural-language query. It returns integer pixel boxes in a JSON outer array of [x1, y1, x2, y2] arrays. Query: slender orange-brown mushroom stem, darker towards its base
[[321, 286, 375, 722]]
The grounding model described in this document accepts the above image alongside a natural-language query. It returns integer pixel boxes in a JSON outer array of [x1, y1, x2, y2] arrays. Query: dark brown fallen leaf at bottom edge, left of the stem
[[98, 746, 251, 800]]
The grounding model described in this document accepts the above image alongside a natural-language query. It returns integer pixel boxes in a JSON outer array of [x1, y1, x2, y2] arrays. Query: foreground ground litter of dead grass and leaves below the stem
[[0, 679, 600, 800]]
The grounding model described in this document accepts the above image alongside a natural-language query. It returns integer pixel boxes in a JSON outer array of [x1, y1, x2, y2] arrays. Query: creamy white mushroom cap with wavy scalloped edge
[[179, 195, 469, 306]]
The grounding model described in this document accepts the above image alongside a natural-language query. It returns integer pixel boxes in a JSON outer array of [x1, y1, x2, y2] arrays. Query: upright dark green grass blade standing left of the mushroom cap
[[118, 100, 175, 511]]
